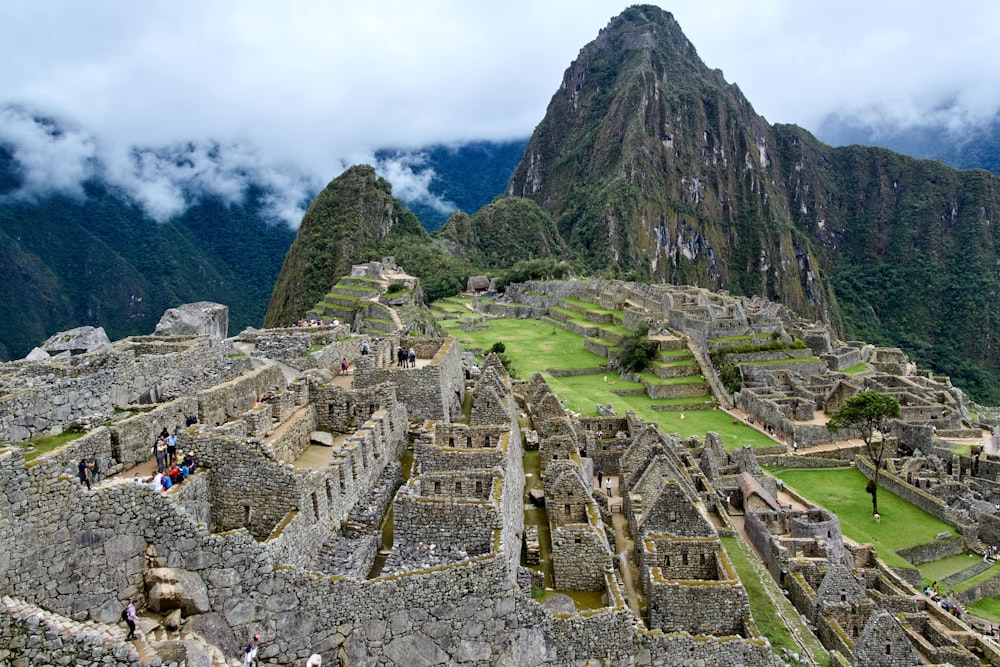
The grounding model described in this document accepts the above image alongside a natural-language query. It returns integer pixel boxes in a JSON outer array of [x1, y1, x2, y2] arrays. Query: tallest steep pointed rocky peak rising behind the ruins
[[508, 6, 831, 317]]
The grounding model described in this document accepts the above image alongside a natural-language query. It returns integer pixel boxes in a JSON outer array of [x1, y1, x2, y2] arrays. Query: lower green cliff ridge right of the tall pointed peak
[[775, 126, 1000, 396]]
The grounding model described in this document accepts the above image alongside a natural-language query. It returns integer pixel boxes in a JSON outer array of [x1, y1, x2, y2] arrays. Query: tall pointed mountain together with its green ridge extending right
[[507, 6, 1000, 403]]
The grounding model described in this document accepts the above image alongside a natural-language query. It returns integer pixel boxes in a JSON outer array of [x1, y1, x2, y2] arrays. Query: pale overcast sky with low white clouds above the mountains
[[0, 0, 1000, 222]]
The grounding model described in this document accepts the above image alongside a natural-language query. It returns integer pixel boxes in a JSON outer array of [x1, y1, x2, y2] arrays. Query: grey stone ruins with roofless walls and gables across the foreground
[[0, 280, 1000, 666]]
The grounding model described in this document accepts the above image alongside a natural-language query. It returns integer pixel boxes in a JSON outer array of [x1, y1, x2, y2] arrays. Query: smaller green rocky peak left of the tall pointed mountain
[[264, 165, 428, 327]]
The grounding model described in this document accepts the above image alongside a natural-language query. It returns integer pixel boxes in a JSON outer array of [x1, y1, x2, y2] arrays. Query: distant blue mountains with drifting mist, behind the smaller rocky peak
[[0, 107, 524, 360]]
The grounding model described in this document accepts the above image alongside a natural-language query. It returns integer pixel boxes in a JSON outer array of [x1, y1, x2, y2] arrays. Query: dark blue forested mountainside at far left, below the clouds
[[0, 148, 295, 360]]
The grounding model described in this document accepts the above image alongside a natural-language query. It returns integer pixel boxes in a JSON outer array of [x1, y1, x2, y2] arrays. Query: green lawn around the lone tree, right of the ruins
[[773, 468, 955, 569]]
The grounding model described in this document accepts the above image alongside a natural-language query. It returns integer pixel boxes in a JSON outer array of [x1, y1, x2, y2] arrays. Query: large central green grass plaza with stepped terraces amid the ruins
[[431, 297, 779, 448]]
